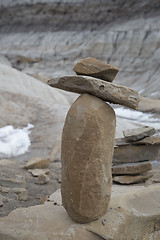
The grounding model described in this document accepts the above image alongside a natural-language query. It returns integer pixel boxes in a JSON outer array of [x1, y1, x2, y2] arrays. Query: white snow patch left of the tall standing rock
[[0, 123, 34, 158]]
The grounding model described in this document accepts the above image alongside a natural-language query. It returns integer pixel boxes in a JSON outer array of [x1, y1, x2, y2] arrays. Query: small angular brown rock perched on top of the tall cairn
[[73, 57, 119, 82]]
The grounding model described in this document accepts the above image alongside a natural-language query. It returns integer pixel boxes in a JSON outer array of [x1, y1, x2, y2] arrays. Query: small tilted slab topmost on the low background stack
[[123, 126, 155, 142]]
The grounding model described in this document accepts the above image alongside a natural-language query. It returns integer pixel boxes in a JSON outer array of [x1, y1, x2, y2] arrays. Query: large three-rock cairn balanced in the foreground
[[48, 58, 152, 223]]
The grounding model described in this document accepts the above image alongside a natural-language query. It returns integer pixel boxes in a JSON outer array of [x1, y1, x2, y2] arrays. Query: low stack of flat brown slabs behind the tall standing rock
[[112, 126, 160, 184]]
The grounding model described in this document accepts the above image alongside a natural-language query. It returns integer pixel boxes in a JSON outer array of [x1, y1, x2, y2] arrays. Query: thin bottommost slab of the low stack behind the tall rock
[[113, 172, 153, 185]]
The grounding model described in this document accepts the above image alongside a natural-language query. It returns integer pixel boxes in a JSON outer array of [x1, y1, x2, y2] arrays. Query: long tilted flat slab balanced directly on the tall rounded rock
[[48, 76, 140, 109]]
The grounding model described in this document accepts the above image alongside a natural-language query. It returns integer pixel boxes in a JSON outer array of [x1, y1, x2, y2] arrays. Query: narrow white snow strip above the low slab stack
[[114, 107, 160, 129]]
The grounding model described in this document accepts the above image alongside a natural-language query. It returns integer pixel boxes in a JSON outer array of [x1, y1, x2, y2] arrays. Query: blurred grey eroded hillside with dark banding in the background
[[0, 0, 160, 98]]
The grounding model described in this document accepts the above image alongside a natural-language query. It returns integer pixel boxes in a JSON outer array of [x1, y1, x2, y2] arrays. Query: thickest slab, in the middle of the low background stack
[[113, 144, 160, 164]]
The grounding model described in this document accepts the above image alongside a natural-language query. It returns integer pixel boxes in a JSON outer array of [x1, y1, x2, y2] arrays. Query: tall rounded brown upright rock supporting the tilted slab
[[61, 94, 116, 223]]
